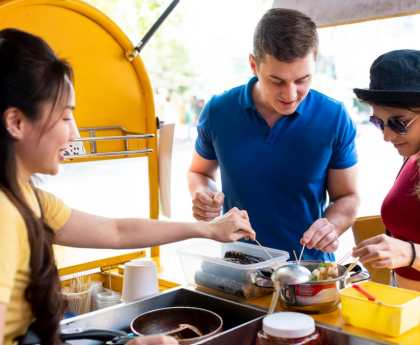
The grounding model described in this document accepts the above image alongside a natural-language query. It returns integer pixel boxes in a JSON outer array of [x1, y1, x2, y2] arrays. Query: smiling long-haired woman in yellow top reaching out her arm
[[0, 29, 255, 345]]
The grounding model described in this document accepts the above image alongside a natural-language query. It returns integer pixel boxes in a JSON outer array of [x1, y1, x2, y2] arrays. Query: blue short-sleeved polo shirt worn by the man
[[195, 77, 357, 260]]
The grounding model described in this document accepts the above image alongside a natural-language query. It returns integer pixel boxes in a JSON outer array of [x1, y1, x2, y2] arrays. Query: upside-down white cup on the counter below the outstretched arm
[[122, 260, 159, 302]]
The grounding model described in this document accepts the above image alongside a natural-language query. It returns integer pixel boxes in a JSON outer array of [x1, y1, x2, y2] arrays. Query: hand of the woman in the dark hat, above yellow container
[[352, 235, 413, 269]]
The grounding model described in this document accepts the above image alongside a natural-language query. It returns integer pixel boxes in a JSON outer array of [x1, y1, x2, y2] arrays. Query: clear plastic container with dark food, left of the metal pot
[[177, 240, 289, 300]]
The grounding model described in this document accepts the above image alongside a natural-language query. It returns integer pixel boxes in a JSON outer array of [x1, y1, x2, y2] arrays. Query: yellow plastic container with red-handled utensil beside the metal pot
[[340, 282, 420, 337]]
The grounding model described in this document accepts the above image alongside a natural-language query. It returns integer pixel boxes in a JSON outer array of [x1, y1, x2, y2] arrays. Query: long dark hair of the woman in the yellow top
[[0, 29, 73, 345]]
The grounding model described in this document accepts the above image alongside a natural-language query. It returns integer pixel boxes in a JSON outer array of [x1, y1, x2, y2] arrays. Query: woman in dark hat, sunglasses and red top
[[353, 50, 420, 291]]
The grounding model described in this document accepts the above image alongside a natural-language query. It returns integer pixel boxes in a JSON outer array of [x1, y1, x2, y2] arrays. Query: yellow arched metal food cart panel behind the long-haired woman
[[0, 0, 159, 250]]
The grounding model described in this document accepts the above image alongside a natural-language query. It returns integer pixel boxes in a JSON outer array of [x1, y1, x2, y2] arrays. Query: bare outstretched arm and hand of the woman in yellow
[[57, 208, 255, 249]]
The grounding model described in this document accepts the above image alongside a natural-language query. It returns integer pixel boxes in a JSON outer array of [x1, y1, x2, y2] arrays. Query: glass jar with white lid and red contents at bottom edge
[[256, 312, 322, 345]]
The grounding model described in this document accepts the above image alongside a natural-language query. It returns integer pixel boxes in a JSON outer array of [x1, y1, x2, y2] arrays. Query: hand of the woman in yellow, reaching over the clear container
[[204, 207, 255, 242]]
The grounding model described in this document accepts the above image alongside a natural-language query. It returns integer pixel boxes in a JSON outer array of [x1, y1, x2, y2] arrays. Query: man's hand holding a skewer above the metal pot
[[300, 218, 338, 253]]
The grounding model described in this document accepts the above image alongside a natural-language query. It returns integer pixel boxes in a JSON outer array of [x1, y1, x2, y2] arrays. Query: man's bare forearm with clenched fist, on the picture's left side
[[187, 149, 225, 222]]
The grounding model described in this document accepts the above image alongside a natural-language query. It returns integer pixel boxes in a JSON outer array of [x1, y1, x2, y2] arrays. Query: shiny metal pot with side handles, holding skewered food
[[253, 260, 370, 314]]
